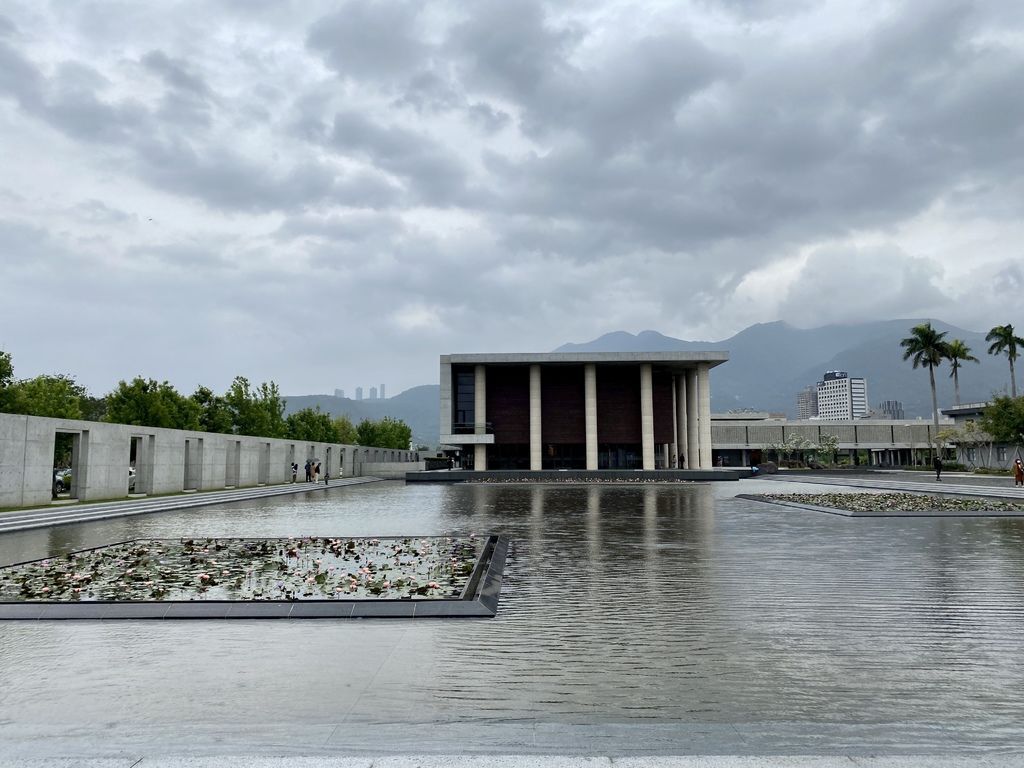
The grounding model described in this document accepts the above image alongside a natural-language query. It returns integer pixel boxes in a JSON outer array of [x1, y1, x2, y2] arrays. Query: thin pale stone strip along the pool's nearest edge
[[0, 757, 1024, 768]]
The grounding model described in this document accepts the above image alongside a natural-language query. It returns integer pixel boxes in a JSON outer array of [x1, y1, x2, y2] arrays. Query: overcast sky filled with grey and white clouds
[[0, 0, 1024, 396]]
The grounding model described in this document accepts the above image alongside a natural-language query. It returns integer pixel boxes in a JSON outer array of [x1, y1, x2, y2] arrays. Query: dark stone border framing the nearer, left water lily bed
[[0, 536, 509, 621]]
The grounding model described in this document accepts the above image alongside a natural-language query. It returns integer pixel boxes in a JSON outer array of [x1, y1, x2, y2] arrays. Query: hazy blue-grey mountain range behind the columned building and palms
[[286, 319, 1010, 445]]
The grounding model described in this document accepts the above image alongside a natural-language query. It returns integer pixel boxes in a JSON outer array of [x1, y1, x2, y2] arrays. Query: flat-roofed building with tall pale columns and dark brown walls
[[440, 351, 729, 471]]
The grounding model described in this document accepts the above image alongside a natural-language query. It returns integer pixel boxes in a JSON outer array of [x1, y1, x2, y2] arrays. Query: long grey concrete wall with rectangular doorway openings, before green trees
[[0, 414, 419, 508]]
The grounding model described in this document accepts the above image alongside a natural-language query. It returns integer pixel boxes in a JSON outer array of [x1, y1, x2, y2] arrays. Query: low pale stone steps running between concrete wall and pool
[[0, 477, 381, 536]]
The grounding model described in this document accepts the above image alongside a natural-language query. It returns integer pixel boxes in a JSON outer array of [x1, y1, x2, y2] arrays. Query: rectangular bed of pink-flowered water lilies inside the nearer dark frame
[[0, 536, 486, 602]]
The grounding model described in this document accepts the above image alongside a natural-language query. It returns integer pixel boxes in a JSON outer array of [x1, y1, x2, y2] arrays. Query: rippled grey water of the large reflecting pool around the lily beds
[[0, 481, 1024, 755]]
